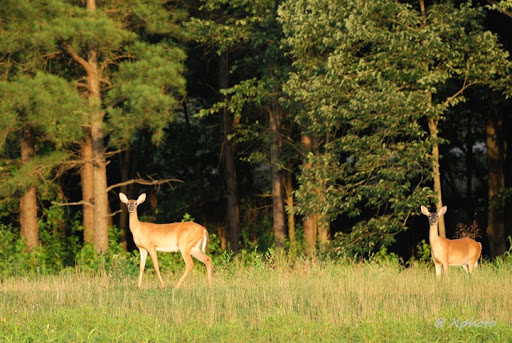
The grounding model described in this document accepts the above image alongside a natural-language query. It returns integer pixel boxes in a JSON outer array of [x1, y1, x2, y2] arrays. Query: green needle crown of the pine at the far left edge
[[0, 72, 84, 197]]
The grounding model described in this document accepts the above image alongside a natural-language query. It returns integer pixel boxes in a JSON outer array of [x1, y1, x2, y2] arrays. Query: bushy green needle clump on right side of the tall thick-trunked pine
[[106, 42, 185, 147]]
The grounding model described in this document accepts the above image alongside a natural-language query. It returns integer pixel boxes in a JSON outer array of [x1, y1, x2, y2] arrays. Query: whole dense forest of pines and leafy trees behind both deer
[[0, 0, 512, 272]]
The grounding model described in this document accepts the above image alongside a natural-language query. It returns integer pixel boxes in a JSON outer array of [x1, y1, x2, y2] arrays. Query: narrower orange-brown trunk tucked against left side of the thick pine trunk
[[80, 133, 94, 244]]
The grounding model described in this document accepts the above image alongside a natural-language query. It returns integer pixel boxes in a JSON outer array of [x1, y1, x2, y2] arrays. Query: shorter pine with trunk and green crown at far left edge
[[0, 73, 83, 249]]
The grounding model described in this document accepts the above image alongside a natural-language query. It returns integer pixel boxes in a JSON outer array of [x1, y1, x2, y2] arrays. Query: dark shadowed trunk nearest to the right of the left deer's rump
[[219, 52, 240, 252]]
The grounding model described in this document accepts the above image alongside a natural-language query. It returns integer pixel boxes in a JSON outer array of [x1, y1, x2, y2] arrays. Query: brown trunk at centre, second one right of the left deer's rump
[[269, 106, 286, 248]]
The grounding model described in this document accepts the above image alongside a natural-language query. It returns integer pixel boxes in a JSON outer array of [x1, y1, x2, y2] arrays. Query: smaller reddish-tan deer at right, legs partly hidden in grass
[[421, 206, 482, 280]]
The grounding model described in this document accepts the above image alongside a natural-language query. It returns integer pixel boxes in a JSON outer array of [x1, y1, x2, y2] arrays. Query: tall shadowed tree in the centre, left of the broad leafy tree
[[189, 0, 294, 253]]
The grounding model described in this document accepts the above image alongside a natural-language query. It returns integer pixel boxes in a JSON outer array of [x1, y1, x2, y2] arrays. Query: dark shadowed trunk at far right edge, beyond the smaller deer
[[485, 109, 507, 258]]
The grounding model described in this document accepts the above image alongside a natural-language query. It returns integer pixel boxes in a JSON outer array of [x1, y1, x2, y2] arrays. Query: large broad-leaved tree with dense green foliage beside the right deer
[[280, 0, 506, 253]]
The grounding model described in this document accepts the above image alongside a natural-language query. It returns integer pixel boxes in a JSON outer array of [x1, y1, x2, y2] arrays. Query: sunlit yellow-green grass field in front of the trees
[[0, 261, 512, 342]]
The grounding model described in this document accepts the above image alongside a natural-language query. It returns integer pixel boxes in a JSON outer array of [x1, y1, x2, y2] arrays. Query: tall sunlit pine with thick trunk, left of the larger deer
[[32, 0, 185, 252]]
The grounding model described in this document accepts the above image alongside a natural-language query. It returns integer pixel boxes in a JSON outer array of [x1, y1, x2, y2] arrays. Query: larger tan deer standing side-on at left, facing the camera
[[119, 193, 212, 289]]
